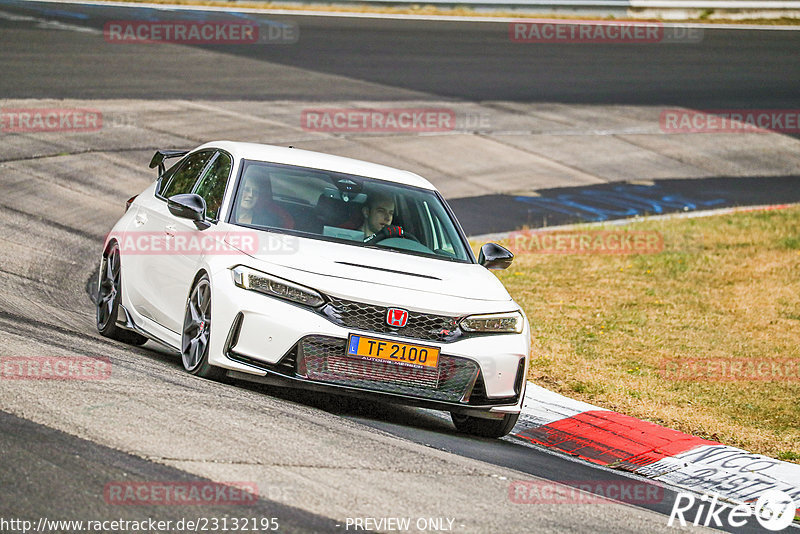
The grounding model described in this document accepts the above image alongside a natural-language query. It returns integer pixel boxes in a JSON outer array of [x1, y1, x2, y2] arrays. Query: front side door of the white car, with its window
[[162, 151, 233, 331]]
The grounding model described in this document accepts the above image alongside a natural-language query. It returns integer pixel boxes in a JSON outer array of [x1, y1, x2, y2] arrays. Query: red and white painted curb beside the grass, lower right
[[512, 382, 800, 515]]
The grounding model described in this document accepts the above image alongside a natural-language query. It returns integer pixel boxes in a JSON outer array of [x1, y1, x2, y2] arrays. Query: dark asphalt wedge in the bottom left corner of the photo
[[0, 412, 336, 532]]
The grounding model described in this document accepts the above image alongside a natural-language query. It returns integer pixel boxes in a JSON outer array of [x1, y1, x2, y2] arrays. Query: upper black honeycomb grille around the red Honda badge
[[322, 297, 462, 343]]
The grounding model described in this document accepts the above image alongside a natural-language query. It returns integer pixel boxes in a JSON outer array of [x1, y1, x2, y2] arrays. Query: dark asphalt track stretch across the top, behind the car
[[0, 0, 800, 109]]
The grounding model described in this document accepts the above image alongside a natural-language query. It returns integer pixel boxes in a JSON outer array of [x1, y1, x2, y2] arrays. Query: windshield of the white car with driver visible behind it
[[229, 160, 472, 262]]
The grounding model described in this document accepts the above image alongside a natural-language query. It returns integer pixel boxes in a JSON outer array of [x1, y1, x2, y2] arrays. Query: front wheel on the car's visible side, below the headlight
[[181, 274, 225, 380]]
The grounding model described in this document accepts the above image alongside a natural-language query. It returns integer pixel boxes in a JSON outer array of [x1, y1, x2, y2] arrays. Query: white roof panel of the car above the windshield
[[195, 141, 436, 190]]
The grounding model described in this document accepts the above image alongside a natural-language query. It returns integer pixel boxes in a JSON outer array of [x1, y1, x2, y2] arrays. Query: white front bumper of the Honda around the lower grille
[[209, 273, 530, 417]]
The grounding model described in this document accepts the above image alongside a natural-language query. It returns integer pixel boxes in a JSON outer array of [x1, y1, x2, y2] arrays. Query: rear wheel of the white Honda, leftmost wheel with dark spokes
[[95, 242, 147, 345]]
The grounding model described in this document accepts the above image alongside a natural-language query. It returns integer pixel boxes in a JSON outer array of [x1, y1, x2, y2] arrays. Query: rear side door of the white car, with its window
[[124, 150, 214, 333]]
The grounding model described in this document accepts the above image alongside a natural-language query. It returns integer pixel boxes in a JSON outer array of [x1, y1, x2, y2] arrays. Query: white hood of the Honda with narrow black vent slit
[[225, 234, 511, 307]]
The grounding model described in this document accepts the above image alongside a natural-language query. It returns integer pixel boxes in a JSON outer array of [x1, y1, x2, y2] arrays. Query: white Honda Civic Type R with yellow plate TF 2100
[[96, 141, 530, 437]]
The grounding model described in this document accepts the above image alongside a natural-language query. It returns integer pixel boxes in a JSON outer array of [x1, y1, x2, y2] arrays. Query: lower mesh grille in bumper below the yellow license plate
[[297, 336, 478, 402]]
